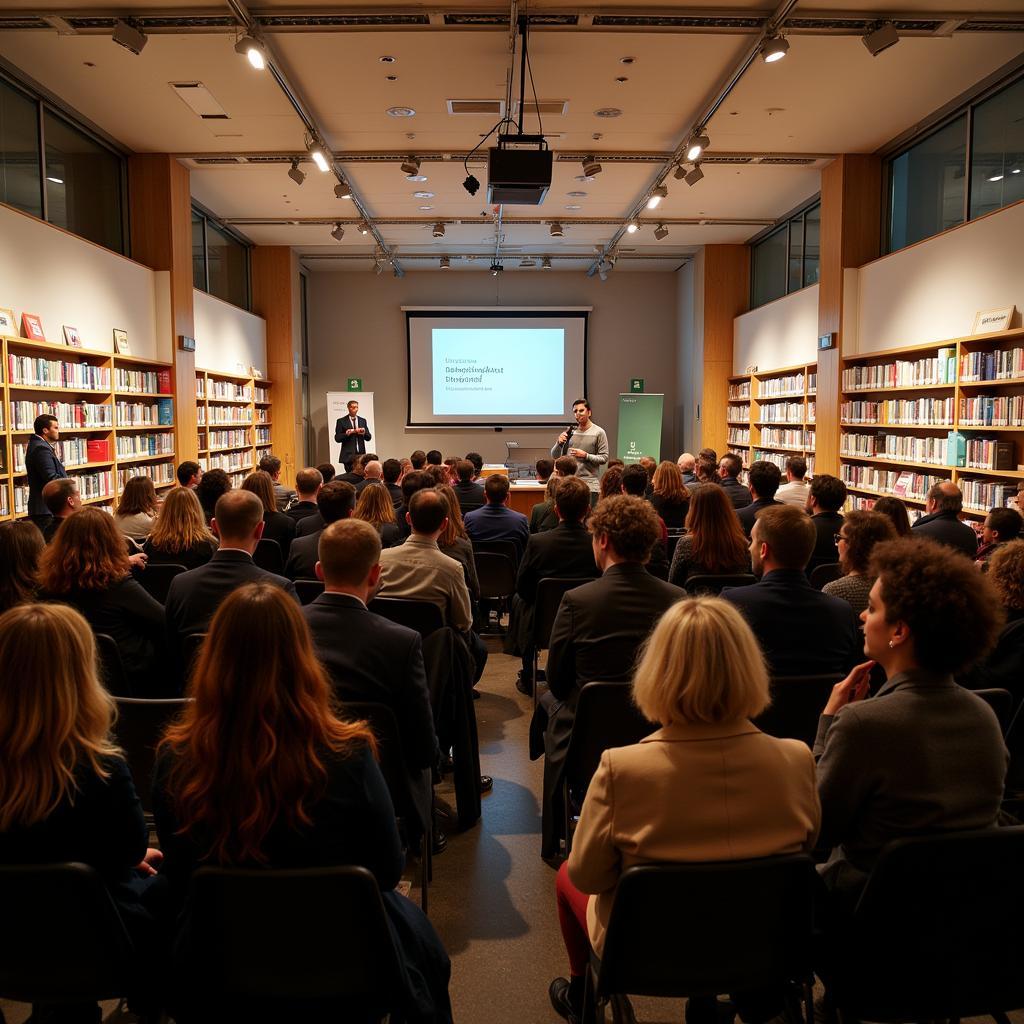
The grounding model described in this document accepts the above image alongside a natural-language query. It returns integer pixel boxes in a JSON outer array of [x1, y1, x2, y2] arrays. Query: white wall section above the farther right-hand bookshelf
[[732, 285, 818, 374]]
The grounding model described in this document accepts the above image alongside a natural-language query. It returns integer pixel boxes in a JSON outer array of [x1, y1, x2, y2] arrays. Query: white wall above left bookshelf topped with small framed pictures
[[0, 204, 172, 360]]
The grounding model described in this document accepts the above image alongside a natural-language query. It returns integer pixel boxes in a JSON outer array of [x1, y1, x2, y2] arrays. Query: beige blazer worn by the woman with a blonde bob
[[568, 719, 821, 955]]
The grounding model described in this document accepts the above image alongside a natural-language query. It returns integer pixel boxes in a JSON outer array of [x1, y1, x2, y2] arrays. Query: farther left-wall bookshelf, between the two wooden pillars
[[196, 370, 273, 486]]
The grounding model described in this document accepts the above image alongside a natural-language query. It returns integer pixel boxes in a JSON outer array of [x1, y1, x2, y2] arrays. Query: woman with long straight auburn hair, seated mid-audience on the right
[[669, 483, 751, 587]]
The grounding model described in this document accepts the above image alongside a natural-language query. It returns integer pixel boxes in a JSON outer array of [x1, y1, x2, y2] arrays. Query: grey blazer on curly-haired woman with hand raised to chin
[[814, 670, 1009, 893]]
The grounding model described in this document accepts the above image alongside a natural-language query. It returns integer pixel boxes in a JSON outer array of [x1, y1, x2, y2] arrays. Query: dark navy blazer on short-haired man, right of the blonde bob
[[722, 569, 863, 680]]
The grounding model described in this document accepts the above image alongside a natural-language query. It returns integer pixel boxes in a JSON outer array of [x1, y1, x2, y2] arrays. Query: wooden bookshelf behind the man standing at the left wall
[[0, 336, 175, 519]]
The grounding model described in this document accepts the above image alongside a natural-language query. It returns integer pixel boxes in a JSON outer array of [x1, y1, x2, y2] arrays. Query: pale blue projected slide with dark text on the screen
[[431, 328, 565, 417]]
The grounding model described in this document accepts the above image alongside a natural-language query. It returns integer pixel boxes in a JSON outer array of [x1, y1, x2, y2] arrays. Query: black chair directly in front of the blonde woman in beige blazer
[[562, 682, 657, 856]]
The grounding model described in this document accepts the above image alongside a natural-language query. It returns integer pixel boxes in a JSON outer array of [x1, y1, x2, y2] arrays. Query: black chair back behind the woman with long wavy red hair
[[178, 866, 402, 1021]]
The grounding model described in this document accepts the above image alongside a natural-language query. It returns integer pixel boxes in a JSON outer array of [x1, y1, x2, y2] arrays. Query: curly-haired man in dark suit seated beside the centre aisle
[[541, 495, 684, 858]]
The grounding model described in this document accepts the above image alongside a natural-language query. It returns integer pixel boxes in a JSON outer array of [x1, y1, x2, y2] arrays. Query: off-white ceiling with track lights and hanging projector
[[0, 0, 1024, 269]]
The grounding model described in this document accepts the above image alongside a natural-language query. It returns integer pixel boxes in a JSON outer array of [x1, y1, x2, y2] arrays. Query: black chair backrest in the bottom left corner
[[0, 864, 135, 1002]]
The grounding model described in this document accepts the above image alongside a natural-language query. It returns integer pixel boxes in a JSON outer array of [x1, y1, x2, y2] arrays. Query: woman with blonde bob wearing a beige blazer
[[549, 598, 820, 1024]]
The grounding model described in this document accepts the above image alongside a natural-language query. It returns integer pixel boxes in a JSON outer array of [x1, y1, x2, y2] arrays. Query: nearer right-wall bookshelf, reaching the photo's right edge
[[840, 329, 1024, 520]]
